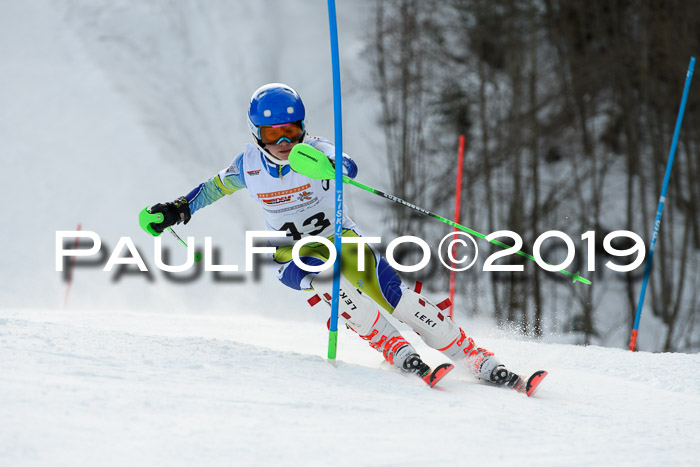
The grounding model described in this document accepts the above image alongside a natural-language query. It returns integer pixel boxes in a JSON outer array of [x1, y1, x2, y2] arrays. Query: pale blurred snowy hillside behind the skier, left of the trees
[[0, 0, 386, 309]]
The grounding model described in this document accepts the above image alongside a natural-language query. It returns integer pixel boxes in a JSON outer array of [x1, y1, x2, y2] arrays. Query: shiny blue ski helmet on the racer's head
[[248, 83, 306, 146]]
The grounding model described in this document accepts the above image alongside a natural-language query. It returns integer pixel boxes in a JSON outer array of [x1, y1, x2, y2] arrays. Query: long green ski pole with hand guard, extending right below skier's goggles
[[289, 144, 591, 285]]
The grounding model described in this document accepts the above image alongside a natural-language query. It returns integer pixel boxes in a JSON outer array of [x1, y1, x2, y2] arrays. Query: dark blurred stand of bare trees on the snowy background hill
[[373, 0, 700, 350]]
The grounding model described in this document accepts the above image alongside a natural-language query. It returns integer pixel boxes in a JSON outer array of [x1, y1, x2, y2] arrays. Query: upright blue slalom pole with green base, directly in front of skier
[[328, 0, 343, 363]]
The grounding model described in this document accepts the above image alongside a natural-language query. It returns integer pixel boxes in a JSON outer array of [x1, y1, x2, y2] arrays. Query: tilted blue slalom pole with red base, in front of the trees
[[629, 57, 695, 352]]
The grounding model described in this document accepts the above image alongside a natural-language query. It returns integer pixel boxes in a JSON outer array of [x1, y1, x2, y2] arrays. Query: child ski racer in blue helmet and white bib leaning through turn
[[147, 83, 544, 395]]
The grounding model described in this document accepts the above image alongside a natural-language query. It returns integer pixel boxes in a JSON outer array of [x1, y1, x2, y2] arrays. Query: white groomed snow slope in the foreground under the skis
[[0, 310, 700, 466]]
